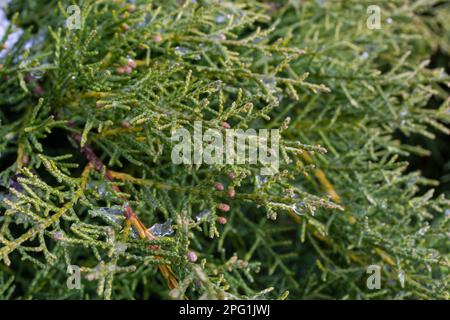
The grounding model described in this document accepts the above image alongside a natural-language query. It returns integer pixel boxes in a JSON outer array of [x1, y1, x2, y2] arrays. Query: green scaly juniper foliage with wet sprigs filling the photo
[[0, 0, 450, 299]]
